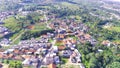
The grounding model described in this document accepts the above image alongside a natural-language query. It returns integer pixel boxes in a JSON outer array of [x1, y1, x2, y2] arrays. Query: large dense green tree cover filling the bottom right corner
[[78, 43, 120, 68]]
